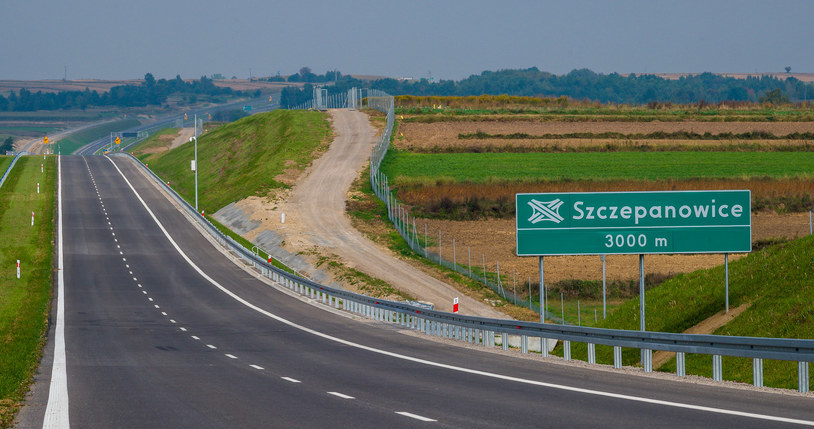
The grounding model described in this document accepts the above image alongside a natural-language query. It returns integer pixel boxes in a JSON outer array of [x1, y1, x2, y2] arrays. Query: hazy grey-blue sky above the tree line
[[0, 0, 814, 79]]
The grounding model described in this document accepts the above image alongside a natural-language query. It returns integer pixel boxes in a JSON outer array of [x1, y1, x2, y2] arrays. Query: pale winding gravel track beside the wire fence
[[242, 110, 506, 318]]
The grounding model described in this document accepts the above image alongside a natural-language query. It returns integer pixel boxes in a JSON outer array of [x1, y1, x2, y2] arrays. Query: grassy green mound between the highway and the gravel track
[[139, 110, 331, 213]]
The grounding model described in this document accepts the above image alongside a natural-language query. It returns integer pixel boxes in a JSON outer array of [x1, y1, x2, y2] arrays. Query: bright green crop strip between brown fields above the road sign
[[382, 149, 814, 185]]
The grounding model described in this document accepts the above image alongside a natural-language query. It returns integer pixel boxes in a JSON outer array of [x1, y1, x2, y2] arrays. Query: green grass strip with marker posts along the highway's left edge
[[0, 157, 56, 427]]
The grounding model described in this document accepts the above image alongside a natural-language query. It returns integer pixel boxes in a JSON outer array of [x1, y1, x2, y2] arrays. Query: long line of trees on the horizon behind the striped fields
[[281, 67, 814, 106]]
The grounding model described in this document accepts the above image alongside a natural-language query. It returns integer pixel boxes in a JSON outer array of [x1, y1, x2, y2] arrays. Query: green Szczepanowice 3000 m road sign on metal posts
[[515, 191, 752, 256]]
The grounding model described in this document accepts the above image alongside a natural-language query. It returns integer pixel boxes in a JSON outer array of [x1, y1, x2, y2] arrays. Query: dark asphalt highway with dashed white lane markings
[[18, 156, 814, 428]]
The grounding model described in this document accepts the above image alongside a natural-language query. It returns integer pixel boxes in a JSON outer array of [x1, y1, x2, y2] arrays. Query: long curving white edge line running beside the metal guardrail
[[106, 156, 814, 426]]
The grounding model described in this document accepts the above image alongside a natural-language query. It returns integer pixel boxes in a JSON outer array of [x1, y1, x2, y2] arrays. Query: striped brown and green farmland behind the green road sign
[[370, 97, 814, 323]]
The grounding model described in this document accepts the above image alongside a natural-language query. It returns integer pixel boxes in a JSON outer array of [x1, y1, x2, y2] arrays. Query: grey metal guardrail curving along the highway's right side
[[115, 150, 814, 392]]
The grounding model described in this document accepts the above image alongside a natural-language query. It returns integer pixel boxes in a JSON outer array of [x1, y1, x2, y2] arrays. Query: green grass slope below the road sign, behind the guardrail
[[552, 237, 814, 388]]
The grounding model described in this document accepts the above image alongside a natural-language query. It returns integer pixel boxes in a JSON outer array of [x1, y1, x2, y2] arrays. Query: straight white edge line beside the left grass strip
[[42, 156, 71, 429]]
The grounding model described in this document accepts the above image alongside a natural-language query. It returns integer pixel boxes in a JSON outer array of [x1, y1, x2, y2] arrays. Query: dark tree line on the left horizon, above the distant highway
[[0, 73, 260, 112]]
